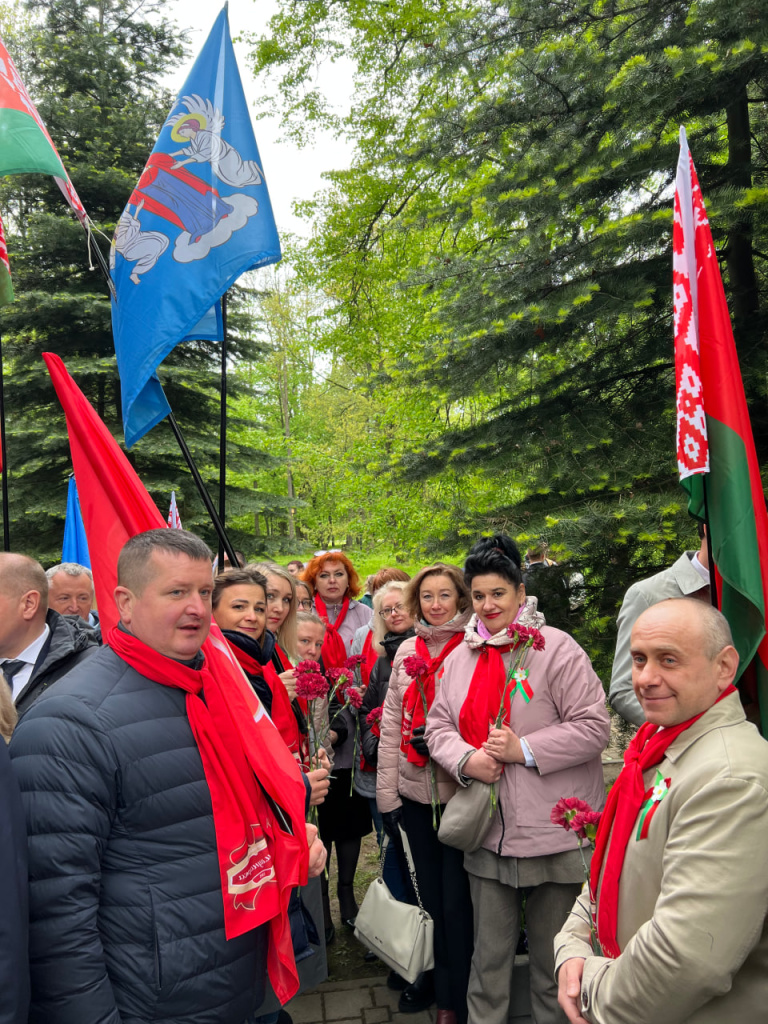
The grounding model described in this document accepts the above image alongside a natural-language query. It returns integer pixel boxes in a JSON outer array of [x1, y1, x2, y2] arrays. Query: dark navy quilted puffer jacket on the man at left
[[10, 647, 267, 1024]]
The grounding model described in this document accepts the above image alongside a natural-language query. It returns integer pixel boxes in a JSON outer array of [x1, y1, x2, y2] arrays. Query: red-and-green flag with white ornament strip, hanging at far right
[[673, 128, 768, 736]]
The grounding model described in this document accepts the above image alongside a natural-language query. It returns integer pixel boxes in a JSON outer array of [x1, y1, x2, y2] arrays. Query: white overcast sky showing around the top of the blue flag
[[165, 0, 352, 237]]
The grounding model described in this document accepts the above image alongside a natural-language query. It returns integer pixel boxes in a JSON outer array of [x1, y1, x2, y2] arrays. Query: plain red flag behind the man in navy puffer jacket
[[43, 352, 308, 1002]]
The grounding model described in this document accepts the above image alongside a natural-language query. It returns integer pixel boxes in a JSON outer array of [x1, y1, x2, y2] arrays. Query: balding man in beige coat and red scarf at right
[[555, 598, 768, 1024]]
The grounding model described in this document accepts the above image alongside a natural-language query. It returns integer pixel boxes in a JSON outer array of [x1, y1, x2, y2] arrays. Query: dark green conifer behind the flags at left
[[0, 0, 278, 561]]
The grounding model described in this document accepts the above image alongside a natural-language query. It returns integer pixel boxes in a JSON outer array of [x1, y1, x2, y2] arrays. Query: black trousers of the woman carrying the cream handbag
[[402, 797, 473, 1024]]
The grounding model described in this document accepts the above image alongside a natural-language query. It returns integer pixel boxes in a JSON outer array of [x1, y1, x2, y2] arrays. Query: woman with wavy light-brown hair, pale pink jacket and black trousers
[[376, 562, 472, 1024]]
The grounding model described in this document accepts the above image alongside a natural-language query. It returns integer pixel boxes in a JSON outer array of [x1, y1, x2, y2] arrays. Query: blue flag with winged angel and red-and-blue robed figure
[[110, 8, 282, 447]]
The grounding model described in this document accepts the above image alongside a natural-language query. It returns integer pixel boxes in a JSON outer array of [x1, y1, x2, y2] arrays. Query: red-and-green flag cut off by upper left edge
[[0, 39, 87, 224]]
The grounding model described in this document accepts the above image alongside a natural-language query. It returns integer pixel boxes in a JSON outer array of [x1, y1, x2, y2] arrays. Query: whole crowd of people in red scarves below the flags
[[0, 529, 768, 1024]]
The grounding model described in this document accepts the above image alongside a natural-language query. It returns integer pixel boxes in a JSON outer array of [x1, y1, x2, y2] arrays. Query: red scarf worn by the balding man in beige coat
[[590, 686, 736, 959]]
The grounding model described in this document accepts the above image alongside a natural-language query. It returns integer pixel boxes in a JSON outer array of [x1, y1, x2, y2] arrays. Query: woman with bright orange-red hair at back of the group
[[301, 551, 373, 942]]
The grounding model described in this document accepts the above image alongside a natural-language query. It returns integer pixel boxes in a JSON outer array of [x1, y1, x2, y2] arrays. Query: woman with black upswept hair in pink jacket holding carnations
[[426, 535, 609, 1024]]
